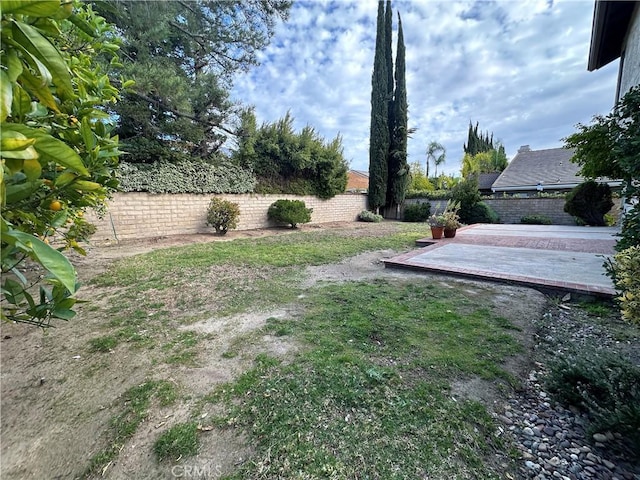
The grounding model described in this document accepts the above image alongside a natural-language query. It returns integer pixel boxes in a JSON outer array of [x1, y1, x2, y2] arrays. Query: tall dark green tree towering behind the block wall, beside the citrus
[[96, 0, 291, 162]]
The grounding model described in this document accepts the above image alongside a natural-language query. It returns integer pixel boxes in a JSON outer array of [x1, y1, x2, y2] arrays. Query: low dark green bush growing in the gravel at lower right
[[545, 350, 640, 452]]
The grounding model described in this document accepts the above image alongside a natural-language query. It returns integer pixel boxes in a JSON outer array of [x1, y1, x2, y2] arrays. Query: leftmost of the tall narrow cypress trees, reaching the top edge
[[368, 1, 389, 212]]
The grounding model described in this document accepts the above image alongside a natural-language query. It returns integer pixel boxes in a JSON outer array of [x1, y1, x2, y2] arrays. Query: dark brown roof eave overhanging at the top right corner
[[587, 0, 637, 72]]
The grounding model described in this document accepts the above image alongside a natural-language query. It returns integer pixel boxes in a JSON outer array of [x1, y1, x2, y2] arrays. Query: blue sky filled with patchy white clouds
[[232, 0, 618, 176]]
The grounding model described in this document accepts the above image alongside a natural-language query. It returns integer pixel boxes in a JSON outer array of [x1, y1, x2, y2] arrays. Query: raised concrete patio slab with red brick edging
[[384, 224, 618, 297]]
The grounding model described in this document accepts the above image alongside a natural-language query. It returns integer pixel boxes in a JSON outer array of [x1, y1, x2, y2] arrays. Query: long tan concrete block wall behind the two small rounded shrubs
[[87, 192, 367, 242]]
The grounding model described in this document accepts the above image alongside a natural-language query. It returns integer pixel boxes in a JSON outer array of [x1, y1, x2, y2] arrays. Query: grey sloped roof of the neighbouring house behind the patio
[[492, 145, 584, 192]]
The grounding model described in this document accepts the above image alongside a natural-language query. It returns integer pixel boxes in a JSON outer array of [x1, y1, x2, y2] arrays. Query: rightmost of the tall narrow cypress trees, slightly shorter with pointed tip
[[387, 13, 409, 209]]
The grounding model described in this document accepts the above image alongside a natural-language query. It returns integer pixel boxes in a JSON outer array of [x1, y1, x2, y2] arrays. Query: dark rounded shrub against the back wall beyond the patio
[[564, 180, 613, 227]]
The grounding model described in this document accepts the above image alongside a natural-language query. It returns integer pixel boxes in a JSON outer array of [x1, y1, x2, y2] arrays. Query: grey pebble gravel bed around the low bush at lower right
[[498, 304, 640, 480]]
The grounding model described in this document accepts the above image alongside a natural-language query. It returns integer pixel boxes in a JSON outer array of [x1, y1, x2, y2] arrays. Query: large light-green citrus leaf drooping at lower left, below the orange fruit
[[2, 229, 76, 293]]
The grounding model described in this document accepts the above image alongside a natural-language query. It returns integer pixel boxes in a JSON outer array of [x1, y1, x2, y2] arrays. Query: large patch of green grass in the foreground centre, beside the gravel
[[210, 280, 521, 479]]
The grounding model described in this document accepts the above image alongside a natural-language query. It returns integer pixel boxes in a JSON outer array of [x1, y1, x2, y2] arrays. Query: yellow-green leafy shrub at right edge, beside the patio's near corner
[[606, 246, 640, 325]]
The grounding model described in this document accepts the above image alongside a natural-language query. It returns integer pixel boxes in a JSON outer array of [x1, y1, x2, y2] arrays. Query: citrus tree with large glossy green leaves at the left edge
[[0, 0, 127, 327]]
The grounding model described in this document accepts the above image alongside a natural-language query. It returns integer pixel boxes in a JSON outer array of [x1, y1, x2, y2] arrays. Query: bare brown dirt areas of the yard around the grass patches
[[0, 223, 568, 479]]
